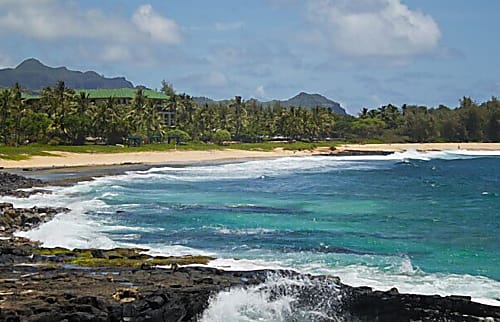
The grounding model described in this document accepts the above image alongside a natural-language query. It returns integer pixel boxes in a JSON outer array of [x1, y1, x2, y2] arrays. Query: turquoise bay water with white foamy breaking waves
[[0, 150, 500, 321]]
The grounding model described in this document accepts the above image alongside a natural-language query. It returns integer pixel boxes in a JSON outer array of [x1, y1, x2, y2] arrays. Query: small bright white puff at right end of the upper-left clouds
[[132, 4, 181, 44]]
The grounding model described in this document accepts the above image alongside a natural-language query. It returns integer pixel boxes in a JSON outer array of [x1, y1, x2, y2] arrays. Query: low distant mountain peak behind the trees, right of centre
[[193, 92, 347, 115]]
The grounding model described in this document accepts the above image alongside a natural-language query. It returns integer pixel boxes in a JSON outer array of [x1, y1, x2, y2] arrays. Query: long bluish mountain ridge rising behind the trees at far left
[[0, 58, 134, 91]]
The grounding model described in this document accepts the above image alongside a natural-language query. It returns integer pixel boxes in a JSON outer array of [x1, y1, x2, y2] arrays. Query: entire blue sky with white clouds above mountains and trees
[[0, 0, 500, 115]]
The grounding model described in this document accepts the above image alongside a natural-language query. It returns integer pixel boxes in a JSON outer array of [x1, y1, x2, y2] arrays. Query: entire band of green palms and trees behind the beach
[[0, 82, 500, 145]]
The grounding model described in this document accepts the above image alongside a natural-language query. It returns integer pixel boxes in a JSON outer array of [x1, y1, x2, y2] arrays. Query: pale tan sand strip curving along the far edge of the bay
[[0, 143, 500, 175]]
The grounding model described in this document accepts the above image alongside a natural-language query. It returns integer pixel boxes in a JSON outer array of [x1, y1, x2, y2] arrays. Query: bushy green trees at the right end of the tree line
[[350, 97, 500, 142]]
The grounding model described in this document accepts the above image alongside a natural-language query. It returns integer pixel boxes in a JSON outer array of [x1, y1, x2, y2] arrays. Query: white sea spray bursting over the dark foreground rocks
[[201, 272, 344, 322]]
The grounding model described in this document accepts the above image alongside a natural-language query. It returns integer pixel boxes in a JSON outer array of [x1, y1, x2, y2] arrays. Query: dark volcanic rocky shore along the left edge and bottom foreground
[[0, 173, 500, 322]]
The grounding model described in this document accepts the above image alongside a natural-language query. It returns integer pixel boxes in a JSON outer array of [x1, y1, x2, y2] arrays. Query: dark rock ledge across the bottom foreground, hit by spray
[[0, 266, 500, 322]]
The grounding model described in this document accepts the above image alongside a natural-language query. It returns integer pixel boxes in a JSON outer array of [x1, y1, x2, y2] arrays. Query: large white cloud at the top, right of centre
[[309, 0, 441, 58]]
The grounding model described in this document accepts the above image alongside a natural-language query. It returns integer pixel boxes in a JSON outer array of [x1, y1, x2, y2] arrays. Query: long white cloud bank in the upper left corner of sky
[[0, 0, 182, 62]]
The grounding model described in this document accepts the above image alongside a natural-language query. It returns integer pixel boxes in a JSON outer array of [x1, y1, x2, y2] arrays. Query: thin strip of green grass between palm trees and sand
[[0, 142, 334, 160]]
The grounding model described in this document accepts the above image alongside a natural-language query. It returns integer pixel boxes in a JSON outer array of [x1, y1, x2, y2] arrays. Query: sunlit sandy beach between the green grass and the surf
[[0, 143, 500, 169]]
